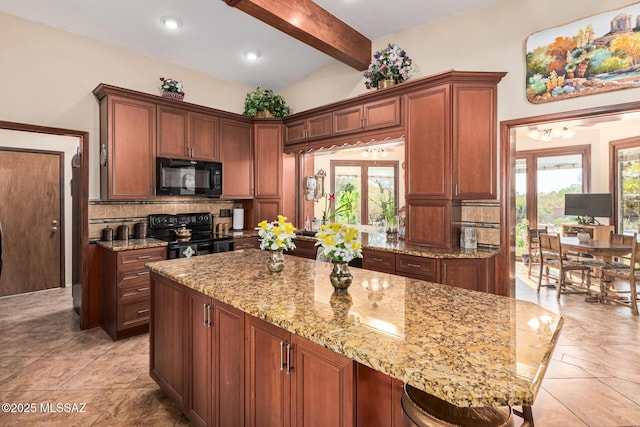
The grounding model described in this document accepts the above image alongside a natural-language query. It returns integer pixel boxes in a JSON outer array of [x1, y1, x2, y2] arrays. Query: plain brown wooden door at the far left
[[0, 149, 64, 296]]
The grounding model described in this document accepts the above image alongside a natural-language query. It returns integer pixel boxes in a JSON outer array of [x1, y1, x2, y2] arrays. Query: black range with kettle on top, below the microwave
[[149, 212, 233, 259]]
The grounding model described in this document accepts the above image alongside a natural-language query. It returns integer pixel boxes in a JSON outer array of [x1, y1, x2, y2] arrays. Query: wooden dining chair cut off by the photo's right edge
[[601, 233, 640, 316]]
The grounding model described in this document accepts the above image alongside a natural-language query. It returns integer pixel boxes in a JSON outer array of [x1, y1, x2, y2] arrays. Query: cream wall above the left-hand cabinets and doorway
[[0, 13, 252, 199]]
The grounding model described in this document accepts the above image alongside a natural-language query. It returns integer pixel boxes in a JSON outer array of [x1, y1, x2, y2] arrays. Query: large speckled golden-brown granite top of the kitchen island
[[147, 249, 563, 407]]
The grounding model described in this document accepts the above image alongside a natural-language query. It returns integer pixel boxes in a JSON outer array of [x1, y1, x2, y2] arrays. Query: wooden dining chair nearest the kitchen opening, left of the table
[[538, 233, 591, 299]]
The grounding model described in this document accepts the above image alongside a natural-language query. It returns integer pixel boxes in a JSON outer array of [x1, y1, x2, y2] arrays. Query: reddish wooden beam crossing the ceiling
[[223, 0, 371, 71]]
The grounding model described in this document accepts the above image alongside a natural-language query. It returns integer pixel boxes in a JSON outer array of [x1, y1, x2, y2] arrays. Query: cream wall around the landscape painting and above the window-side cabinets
[[281, 0, 640, 122]]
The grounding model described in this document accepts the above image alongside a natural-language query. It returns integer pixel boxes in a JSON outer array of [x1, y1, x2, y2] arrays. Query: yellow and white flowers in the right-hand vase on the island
[[316, 222, 362, 262]]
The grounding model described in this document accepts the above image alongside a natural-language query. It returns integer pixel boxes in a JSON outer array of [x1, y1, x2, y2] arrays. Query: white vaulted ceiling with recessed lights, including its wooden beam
[[0, 0, 508, 91]]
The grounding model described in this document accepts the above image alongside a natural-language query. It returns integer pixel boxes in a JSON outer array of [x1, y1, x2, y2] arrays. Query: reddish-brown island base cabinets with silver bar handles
[[150, 273, 355, 427]]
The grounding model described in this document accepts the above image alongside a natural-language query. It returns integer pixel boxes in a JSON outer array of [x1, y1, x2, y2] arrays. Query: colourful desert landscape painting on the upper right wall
[[526, 3, 640, 104]]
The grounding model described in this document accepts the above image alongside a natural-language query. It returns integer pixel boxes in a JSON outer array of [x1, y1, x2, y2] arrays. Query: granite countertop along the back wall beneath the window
[[231, 230, 499, 258]]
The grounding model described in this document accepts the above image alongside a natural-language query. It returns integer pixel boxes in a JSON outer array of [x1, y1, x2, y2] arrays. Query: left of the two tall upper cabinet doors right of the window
[[405, 85, 451, 198]]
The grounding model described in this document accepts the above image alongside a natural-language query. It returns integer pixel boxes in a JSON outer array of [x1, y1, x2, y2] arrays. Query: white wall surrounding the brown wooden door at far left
[[0, 129, 79, 286]]
